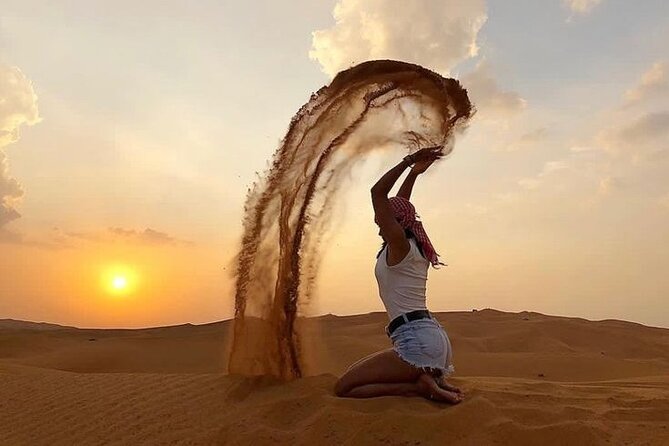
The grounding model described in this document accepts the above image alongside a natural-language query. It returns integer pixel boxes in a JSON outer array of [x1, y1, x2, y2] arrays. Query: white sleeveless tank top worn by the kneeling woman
[[374, 238, 430, 320]]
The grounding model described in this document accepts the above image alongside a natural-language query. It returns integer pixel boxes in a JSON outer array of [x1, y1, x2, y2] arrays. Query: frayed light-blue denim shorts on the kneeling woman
[[390, 319, 453, 376]]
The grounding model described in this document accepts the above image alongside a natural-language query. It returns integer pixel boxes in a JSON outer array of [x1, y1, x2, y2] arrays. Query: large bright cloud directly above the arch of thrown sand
[[309, 0, 487, 77]]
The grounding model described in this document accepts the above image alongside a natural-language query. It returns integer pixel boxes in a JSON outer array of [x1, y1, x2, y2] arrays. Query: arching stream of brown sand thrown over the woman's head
[[228, 60, 473, 379]]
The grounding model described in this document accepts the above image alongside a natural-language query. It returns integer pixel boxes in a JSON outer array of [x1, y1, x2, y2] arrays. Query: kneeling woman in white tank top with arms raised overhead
[[335, 147, 463, 404]]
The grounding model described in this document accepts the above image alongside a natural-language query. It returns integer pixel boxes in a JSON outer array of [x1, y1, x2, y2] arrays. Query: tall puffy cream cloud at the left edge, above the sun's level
[[0, 65, 39, 230]]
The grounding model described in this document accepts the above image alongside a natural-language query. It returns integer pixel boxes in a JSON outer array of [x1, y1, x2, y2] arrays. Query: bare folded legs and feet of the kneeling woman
[[335, 349, 460, 403]]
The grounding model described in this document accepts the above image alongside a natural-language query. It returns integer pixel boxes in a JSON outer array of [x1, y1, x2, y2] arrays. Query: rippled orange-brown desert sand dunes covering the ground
[[0, 310, 669, 446]]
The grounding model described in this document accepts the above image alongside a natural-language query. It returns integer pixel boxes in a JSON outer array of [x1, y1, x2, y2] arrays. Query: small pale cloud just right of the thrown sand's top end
[[461, 61, 537, 120]]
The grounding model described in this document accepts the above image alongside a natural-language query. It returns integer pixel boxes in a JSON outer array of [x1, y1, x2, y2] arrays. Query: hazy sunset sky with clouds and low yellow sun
[[0, 0, 669, 327]]
